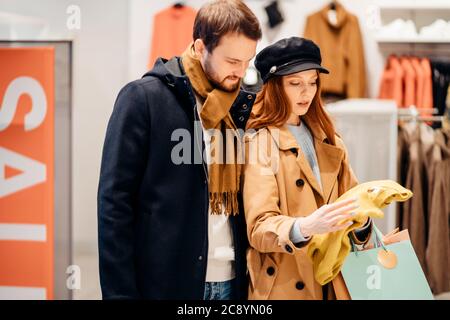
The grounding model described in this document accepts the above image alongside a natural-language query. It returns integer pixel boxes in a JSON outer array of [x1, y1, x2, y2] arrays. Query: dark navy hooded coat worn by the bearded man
[[98, 58, 255, 299]]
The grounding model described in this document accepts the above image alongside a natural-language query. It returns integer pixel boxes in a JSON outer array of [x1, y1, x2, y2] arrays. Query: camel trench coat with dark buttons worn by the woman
[[243, 120, 369, 300]]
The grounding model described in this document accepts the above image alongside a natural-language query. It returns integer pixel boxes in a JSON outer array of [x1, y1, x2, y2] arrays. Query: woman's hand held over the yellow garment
[[299, 198, 358, 238]]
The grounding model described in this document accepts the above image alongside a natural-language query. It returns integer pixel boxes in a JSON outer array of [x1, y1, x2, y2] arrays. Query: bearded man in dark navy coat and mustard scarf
[[98, 0, 261, 299]]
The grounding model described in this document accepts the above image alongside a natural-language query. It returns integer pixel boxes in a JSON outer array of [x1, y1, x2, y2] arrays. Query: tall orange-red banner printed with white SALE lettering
[[0, 47, 54, 299]]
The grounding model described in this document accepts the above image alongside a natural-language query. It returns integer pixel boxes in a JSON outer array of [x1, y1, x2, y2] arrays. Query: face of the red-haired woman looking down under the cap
[[283, 69, 318, 118]]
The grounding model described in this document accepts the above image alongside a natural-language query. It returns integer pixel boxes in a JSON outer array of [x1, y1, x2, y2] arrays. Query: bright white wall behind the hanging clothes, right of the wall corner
[[128, 0, 384, 97]]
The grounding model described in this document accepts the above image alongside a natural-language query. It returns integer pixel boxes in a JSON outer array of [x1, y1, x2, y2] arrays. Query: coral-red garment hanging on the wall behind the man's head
[[148, 6, 197, 69]]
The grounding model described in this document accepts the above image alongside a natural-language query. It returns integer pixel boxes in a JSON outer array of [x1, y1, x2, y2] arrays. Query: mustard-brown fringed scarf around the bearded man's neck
[[181, 44, 242, 215]]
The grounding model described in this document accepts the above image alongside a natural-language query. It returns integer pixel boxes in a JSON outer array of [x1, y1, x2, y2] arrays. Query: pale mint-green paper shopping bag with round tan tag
[[341, 225, 433, 300]]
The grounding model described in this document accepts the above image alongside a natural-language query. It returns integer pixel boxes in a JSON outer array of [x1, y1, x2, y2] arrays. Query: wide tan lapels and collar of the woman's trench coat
[[268, 119, 345, 203]]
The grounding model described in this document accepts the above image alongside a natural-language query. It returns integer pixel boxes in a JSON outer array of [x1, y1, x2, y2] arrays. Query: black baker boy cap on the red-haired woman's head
[[255, 37, 330, 83]]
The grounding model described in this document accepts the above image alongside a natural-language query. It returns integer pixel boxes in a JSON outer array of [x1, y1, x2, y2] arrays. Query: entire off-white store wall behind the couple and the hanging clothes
[[0, 0, 448, 298]]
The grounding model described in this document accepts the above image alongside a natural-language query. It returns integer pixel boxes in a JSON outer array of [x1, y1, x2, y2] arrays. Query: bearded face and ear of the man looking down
[[194, 34, 257, 92]]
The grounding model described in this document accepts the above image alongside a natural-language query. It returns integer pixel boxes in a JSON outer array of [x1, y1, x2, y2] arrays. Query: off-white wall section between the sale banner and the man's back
[[0, 0, 130, 256]]
